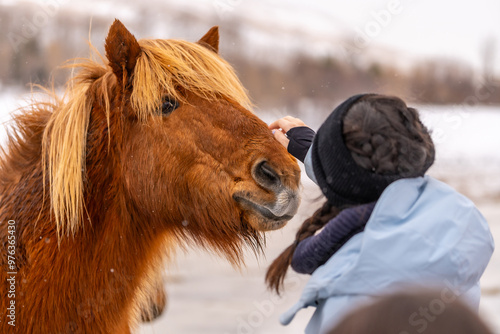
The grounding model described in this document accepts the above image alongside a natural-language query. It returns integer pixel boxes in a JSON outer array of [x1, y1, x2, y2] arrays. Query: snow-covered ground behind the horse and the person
[[0, 92, 500, 334]]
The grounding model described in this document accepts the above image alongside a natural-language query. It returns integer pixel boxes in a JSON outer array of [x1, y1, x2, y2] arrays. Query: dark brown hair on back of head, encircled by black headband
[[343, 95, 434, 178]]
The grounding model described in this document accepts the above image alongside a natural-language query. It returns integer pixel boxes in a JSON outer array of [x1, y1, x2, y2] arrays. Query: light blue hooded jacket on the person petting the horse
[[280, 176, 494, 334]]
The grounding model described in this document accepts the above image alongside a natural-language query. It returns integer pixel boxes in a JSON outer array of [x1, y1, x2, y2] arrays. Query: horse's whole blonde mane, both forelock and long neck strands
[[42, 40, 252, 240]]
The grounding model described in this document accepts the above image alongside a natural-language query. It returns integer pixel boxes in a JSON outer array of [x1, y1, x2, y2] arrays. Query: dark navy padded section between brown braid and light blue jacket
[[291, 202, 376, 274]]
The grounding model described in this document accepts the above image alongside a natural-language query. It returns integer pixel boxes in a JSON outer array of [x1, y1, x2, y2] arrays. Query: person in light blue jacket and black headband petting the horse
[[266, 94, 494, 333]]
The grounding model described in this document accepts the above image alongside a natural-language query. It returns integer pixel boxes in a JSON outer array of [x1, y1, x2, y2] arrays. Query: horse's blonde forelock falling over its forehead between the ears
[[131, 40, 252, 120]]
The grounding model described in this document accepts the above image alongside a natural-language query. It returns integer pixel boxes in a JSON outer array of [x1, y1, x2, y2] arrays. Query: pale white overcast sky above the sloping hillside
[[167, 0, 500, 73]]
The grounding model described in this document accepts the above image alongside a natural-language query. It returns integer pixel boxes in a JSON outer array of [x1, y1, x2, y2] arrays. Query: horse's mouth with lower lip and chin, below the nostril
[[233, 195, 296, 231]]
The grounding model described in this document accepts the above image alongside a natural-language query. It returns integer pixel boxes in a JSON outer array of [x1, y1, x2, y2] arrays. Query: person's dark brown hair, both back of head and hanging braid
[[266, 95, 435, 294]]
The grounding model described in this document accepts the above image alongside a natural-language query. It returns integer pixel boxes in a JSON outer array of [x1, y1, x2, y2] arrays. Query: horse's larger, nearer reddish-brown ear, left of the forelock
[[104, 19, 141, 80]]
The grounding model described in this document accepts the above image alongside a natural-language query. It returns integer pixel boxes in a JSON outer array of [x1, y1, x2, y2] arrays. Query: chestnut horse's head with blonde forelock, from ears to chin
[[91, 21, 300, 260]]
